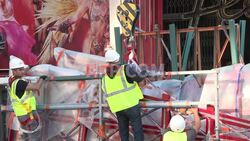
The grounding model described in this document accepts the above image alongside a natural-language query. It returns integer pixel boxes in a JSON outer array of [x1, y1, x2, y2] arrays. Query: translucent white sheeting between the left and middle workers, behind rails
[[29, 64, 98, 140]]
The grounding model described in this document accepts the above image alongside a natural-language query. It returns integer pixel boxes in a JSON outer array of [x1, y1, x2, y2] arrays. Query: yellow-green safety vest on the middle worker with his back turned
[[102, 65, 143, 113]]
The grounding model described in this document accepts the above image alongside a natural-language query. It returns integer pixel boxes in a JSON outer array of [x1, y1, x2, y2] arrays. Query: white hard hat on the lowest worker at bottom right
[[169, 115, 186, 132]]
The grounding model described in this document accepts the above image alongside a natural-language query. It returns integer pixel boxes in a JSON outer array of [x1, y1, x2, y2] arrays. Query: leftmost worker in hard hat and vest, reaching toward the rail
[[9, 55, 46, 141]]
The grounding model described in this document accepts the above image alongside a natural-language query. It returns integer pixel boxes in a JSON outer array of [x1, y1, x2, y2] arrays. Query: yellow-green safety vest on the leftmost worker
[[10, 79, 36, 116]]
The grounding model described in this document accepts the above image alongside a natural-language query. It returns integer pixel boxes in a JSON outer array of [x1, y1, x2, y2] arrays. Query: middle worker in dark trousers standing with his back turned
[[102, 49, 146, 141]]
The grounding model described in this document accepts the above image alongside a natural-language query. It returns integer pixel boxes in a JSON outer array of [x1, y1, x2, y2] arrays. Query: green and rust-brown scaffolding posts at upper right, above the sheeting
[[135, 20, 246, 71]]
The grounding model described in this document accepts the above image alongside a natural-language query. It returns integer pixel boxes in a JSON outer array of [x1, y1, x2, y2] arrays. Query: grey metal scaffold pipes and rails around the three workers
[[0, 70, 228, 141]]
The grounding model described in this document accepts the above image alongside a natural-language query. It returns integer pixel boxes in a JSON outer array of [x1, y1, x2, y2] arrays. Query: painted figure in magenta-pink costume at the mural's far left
[[0, 0, 36, 68]]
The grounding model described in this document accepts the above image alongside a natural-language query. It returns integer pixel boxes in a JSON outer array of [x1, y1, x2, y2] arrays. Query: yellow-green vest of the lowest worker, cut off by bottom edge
[[163, 131, 187, 141]]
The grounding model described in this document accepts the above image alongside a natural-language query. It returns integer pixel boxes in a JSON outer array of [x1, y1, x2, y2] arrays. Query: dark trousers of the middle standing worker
[[116, 104, 144, 141]]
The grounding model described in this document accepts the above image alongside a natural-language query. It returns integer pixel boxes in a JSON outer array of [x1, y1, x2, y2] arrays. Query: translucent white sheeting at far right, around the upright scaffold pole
[[199, 64, 250, 116]]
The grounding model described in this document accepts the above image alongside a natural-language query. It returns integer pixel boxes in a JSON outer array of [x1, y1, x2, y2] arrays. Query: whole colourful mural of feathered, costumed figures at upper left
[[0, 0, 109, 69]]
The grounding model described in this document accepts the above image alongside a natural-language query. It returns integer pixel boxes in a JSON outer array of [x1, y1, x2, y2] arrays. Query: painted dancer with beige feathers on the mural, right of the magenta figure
[[38, 0, 109, 63]]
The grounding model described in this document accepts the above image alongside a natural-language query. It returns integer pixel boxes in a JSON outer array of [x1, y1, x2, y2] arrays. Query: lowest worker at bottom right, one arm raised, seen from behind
[[163, 108, 201, 141]]
